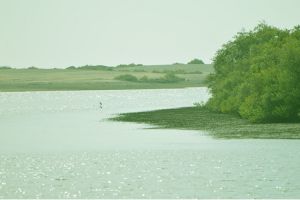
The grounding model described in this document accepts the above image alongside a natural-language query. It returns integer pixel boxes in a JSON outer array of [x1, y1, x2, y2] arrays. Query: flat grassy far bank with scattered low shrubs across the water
[[0, 65, 213, 91]]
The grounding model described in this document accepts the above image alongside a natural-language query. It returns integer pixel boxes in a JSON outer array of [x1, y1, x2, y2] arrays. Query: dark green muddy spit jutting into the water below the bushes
[[112, 107, 300, 139]]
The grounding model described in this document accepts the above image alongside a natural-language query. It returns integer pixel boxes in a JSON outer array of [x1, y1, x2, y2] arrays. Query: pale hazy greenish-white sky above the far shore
[[0, 0, 300, 68]]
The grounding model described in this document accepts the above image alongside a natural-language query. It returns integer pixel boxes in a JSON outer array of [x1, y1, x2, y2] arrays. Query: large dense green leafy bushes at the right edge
[[207, 24, 300, 122]]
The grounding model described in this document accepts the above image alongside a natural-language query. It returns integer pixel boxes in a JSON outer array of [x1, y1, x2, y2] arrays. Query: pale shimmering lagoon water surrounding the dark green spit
[[0, 88, 300, 198]]
